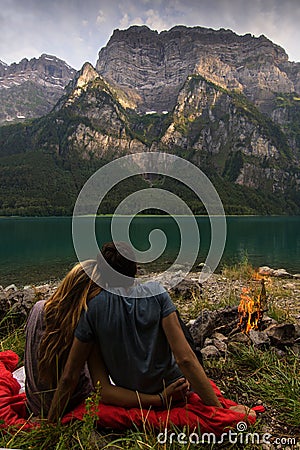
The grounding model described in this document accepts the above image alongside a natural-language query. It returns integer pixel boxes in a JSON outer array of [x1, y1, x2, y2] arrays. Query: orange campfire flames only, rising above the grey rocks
[[238, 273, 267, 334]]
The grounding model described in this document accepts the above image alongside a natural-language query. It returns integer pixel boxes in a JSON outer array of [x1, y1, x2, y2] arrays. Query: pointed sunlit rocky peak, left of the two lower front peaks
[[56, 63, 147, 159]]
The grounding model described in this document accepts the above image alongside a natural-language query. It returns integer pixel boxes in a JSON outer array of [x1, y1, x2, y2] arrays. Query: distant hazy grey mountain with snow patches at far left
[[0, 54, 76, 124]]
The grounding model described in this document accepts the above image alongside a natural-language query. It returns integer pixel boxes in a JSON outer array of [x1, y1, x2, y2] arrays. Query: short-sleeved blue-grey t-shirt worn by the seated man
[[75, 282, 182, 394]]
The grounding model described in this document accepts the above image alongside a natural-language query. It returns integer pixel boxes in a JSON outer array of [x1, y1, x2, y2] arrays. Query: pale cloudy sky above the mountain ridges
[[0, 0, 300, 69]]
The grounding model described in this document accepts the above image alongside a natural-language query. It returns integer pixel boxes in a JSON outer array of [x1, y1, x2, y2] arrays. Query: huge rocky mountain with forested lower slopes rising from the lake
[[0, 26, 300, 214]]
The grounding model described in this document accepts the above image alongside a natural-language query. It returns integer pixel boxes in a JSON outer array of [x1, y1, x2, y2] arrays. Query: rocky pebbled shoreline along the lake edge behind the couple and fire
[[0, 266, 300, 325]]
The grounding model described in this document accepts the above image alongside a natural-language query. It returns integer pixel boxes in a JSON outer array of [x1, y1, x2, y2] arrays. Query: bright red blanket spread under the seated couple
[[0, 350, 262, 435]]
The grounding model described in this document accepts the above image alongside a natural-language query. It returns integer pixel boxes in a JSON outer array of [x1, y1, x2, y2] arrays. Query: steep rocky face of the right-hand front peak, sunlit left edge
[[154, 75, 300, 192]]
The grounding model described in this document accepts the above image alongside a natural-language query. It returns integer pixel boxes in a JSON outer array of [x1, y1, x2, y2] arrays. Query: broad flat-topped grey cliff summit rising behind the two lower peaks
[[96, 26, 300, 116]]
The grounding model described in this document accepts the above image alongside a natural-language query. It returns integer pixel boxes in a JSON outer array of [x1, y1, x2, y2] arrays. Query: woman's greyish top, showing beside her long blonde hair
[[24, 300, 93, 417]]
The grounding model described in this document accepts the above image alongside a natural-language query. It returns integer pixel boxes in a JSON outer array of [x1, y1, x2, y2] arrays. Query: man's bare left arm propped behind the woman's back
[[48, 337, 93, 422]]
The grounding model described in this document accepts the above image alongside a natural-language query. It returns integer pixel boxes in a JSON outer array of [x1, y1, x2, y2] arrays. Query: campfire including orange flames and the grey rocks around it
[[189, 273, 300, 360]]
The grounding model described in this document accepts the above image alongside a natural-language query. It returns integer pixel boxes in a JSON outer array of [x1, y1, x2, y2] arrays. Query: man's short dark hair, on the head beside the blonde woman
[[97, 242, 137, 287]]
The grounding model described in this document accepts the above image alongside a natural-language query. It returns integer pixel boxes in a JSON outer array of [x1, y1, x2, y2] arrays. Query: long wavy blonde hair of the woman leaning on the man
[[38, 260, 101, 388]]
